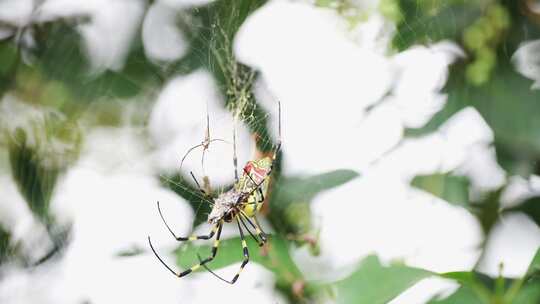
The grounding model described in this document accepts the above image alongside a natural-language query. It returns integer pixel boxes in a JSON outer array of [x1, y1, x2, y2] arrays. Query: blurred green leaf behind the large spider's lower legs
[[176, 235, 302, 286]]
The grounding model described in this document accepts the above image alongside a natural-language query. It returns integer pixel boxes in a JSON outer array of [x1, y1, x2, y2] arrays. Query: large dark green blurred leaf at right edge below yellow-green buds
[[407, 54, 540, 176]]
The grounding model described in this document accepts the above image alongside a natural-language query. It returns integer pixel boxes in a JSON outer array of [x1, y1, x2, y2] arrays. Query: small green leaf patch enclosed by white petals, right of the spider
[[411, 173, 470, 206]]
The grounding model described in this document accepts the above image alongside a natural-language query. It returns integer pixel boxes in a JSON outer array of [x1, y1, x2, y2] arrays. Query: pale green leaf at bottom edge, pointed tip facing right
[[335, 256, 434, 304]]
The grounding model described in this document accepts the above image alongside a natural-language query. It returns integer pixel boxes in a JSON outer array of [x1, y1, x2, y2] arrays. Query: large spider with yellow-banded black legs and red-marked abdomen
[[148, 102, 281, 284]]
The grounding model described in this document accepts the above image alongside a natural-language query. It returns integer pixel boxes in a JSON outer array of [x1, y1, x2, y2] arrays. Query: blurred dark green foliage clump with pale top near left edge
[[5, 112, 81, 225]]
